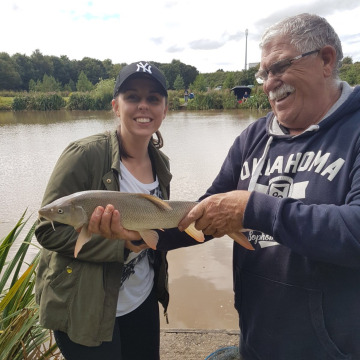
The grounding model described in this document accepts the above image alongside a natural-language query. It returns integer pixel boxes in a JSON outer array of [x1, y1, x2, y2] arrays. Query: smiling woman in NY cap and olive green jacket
[[36, 62, 171, 360]]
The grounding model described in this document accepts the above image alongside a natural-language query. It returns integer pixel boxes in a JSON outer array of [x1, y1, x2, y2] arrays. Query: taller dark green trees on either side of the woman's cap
[[0, 49, 199, 91]]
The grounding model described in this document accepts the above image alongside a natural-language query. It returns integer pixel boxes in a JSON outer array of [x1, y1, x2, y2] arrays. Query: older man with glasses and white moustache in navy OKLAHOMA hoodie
[[89, 14, 360, 360]]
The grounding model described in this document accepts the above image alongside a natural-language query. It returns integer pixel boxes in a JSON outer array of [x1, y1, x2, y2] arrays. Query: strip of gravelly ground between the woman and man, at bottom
[[160, 329, 239, 360]]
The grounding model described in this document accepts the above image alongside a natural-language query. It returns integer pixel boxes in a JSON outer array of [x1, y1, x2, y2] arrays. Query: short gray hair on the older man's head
[[260, 13, 343, 77]]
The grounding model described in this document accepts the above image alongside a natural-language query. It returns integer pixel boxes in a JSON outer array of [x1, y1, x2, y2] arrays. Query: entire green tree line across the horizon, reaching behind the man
[[0, 49, 360, 92]]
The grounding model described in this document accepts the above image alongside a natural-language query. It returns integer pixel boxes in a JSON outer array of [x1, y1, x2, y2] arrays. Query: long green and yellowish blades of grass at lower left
[[0, 211, 61, 360]]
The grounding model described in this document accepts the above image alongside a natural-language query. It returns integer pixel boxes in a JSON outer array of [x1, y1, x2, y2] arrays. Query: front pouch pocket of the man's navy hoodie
[[235, 271, 350, 360]]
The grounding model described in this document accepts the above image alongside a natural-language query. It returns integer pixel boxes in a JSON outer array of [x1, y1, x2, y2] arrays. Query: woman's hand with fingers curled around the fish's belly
[[88, 204, 141, 240]]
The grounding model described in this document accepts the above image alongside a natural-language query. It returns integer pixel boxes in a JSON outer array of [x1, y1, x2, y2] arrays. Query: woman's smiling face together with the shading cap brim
[[112, 77, 168, 141]]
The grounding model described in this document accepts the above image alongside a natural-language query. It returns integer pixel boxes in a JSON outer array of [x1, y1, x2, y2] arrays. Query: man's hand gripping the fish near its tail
[[178, 190, 250, 237]]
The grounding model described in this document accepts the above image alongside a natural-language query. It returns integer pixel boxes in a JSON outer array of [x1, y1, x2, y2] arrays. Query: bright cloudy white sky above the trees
[[0, 0, 360, 73]]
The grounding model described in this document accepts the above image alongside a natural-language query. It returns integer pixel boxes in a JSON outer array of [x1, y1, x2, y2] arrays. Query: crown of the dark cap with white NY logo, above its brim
[[113, 61, 168, 99]]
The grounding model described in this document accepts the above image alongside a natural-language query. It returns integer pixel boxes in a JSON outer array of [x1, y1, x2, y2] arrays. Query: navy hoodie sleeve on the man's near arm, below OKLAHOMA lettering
[[243, 176, 360, 267]]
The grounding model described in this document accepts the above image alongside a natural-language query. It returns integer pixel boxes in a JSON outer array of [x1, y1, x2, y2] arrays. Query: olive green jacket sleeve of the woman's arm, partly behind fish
[[35, 142, 124, 262]]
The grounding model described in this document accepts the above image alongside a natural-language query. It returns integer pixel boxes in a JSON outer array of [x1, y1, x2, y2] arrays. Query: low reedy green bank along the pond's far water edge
[[0, 87, 270, 111]]
